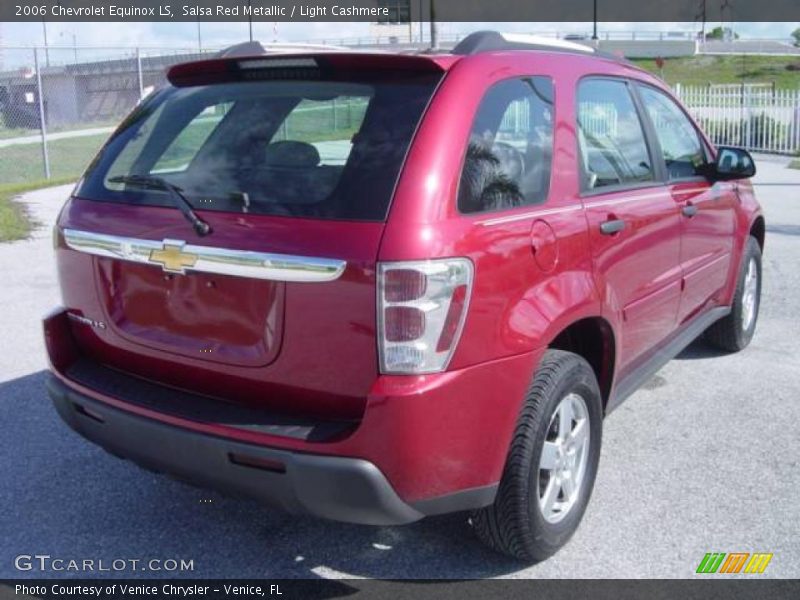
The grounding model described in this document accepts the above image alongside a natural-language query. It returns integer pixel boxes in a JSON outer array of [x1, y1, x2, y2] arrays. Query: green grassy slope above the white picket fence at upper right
[[633, 54, 800, 90]]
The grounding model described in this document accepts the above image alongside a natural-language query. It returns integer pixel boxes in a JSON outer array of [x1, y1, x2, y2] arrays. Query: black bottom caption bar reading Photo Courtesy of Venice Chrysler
[[0, 578, 800, 600]]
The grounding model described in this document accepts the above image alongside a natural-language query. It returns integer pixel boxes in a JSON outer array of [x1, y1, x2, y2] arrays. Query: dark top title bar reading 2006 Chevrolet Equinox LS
[[0, 0, 800, 22]]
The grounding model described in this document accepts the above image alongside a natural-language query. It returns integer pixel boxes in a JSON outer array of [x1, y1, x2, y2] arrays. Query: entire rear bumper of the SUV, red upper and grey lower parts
[[44, 309, 538, 525]]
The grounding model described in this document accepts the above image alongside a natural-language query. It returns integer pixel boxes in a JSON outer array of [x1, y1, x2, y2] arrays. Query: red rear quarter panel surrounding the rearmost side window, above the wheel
[[379, 55, 600, 368]]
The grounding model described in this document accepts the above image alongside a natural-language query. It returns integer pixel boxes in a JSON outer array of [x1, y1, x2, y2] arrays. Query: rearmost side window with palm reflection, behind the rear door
[[458, 76, 554, 213]]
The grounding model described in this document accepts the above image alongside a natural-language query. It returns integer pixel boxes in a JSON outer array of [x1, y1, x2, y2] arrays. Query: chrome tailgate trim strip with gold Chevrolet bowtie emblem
[[64, 229, 347, 283]]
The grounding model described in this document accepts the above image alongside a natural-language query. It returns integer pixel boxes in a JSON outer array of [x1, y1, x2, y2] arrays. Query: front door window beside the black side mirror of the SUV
[[639, 87, 706, 179]]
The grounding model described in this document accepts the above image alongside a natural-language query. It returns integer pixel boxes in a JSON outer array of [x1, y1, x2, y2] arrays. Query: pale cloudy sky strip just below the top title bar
[[0, 22, 800, 48]]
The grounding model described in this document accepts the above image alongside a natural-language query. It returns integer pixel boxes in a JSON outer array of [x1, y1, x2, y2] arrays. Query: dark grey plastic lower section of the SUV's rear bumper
[[47, 375, 424, 525]]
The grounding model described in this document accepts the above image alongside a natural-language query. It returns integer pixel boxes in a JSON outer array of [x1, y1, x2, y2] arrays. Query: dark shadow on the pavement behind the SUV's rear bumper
[[0, 371, 524, 580]]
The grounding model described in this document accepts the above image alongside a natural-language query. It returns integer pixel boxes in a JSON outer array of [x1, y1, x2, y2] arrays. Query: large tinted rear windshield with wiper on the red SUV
[[77, 74, 439, 221]]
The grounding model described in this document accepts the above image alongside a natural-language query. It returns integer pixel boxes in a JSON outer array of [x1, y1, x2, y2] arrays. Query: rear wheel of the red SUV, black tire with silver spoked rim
[[471, 350, 603, 563]]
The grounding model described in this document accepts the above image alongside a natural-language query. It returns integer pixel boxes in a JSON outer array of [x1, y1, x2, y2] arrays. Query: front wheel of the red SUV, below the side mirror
[[705, 237, 761, 352]]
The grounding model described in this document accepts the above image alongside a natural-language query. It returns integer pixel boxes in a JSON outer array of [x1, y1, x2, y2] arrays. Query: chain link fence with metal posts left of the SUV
[[0, 47, 209, 185]]
